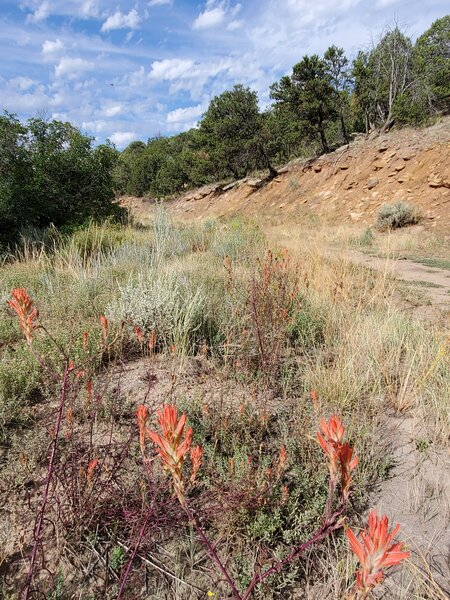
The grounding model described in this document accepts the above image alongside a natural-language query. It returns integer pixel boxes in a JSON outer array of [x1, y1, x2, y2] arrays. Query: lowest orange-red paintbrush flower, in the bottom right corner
[[345, 510, 410, 598]]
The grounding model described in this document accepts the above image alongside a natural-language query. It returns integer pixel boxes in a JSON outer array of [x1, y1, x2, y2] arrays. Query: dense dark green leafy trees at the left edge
[[0, 113, 121, 250]]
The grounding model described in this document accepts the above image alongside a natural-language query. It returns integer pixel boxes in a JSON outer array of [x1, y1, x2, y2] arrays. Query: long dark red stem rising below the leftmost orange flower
[[23, 361, 70, 600]]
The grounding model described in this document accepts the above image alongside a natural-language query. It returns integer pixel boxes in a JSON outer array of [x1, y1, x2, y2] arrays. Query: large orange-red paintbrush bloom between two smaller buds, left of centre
[[147, 404, 192, 506]]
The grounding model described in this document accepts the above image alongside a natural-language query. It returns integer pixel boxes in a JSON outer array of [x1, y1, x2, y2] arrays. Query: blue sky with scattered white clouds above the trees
[[0, 0, 450, 149]]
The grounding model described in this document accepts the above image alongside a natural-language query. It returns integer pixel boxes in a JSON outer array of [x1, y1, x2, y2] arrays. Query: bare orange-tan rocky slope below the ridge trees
[[133, 117, 450, 232]]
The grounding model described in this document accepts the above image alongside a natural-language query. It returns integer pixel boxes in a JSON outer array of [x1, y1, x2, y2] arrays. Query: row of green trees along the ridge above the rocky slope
[[115, 15, 450, 198]]
